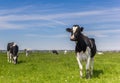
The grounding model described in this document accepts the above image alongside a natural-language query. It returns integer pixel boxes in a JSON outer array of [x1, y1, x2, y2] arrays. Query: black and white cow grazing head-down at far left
[[7, 42, 19, 64]]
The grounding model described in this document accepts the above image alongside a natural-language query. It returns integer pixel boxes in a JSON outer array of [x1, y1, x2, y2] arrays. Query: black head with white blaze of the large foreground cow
[[66, 25, 84, 41]]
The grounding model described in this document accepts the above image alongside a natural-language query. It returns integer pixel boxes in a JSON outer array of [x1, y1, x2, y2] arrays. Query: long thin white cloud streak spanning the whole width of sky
[[1, 8, 120, 21]]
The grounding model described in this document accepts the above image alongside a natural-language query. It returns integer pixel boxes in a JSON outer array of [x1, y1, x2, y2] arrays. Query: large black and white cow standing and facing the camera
[[66, 25, 96, 78]]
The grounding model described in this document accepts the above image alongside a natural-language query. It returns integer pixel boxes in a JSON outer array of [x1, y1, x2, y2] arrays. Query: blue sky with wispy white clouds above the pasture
[[0, 0, 120, 50]]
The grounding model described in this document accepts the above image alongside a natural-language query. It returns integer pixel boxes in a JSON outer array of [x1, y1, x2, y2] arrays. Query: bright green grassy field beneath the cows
[[0, 52, 120, 83]]
